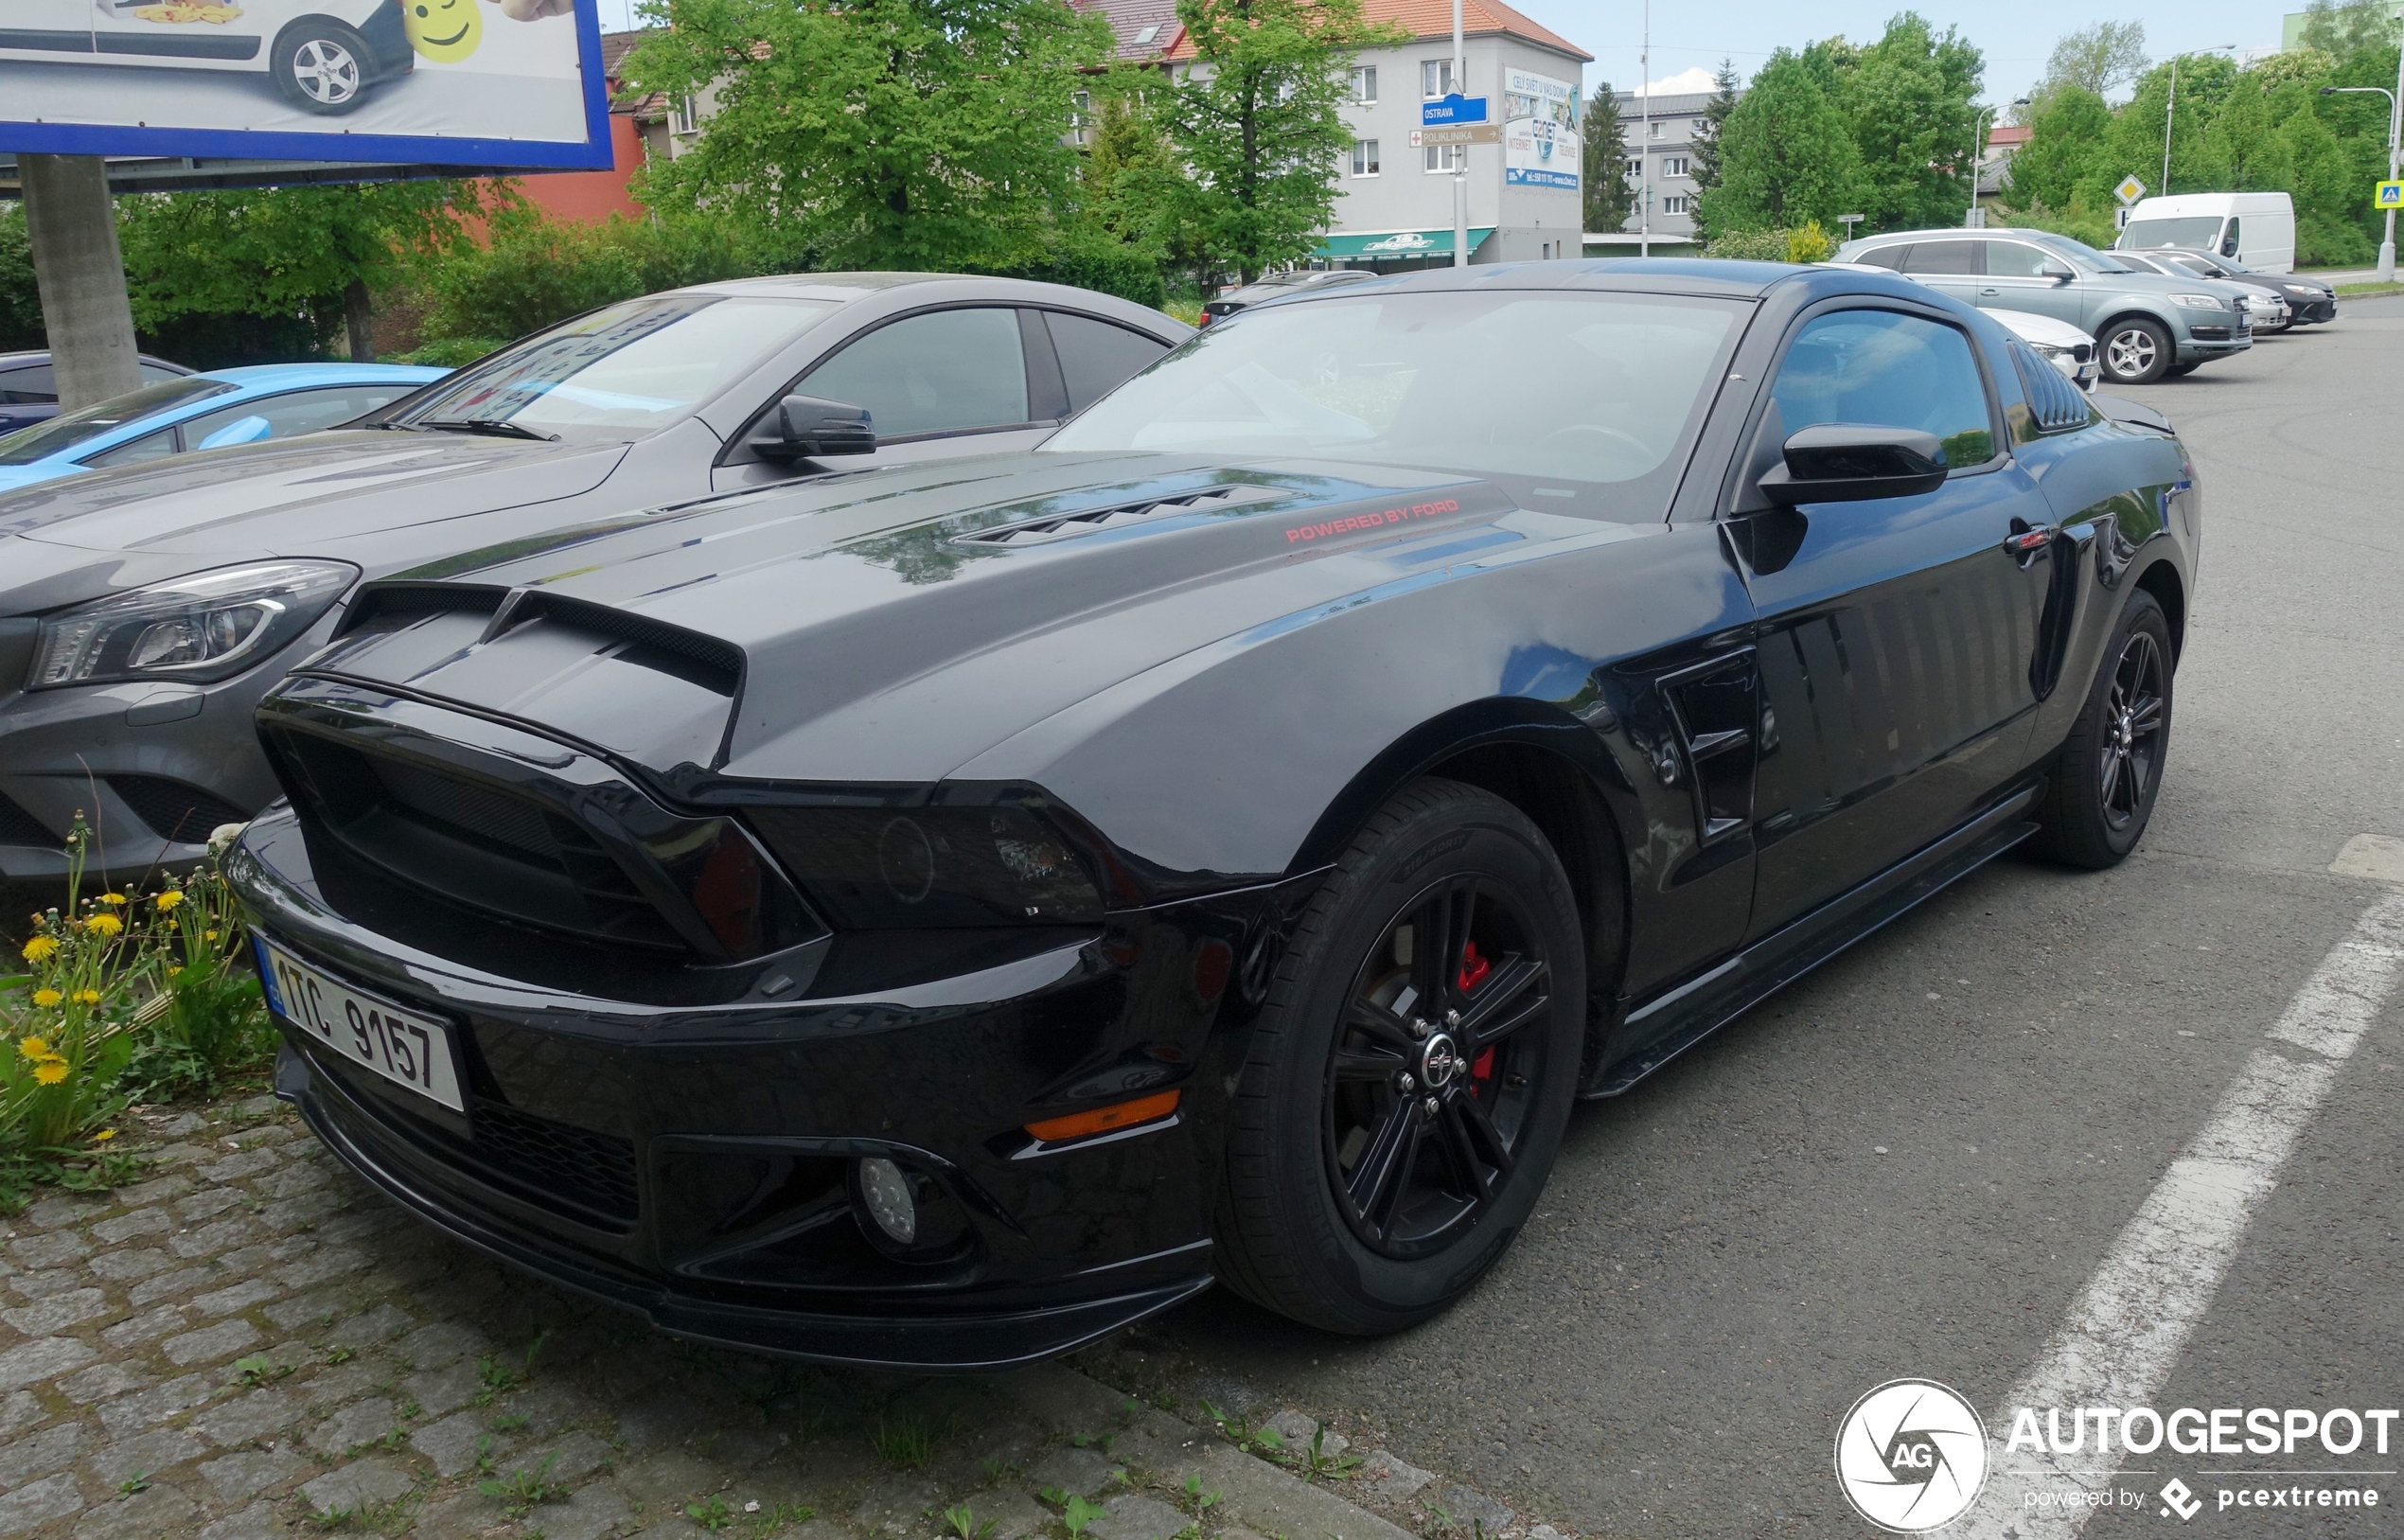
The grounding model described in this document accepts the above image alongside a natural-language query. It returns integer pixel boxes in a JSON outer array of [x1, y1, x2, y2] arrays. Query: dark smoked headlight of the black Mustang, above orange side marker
[[745, 805, 1104, 929]]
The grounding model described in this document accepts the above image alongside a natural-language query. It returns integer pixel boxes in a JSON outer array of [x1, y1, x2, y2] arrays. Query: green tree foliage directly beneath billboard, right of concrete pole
[[117, 180, 492, 361]]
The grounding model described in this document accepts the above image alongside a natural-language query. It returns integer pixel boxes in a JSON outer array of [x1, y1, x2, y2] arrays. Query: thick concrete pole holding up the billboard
[[17, 153, 142, 411]]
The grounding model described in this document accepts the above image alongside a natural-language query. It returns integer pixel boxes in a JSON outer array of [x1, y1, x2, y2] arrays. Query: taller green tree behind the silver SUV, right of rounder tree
[[1839, 9, 1986, 231]]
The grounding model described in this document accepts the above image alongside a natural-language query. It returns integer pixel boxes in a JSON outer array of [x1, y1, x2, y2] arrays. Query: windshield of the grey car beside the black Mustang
[[384, 293, 832, 433]]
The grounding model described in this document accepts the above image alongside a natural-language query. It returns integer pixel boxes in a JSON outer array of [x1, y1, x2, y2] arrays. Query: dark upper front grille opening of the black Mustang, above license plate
[[269, 733, 687, 954]]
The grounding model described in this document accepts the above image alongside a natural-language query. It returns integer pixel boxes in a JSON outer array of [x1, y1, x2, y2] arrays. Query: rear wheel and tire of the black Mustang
[[2041, 591, 2171, 867]]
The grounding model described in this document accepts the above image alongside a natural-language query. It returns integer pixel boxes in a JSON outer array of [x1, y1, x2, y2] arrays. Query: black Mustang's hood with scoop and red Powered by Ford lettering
[[303, 454, 1615, 783]]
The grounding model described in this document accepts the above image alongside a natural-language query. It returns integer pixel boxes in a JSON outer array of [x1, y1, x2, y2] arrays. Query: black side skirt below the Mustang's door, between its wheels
[[1582, 786, 2039, 1101]]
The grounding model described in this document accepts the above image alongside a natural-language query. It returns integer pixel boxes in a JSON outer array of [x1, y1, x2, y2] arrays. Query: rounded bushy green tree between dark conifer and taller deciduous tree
[[1702, 48, 1861, 238]]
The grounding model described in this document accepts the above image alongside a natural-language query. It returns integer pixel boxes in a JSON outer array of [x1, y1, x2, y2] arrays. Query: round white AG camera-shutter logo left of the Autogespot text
[[1837, 1379, 1986, 1535]]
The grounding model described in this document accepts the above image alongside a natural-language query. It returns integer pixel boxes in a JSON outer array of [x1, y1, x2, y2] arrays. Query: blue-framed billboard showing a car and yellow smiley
[[0, 0, 610, 168]]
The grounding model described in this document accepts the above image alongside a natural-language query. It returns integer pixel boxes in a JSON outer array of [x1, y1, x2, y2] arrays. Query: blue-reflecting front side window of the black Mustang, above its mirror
[[1769, 310, 1995, 470]]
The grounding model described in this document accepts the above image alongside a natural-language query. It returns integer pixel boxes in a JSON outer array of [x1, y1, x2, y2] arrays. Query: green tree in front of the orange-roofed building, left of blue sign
[[1144, 0, 1408, 284]]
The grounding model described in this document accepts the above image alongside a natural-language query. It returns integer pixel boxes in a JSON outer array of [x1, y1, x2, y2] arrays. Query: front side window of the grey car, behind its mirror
[[793, 308, 1027, 439]]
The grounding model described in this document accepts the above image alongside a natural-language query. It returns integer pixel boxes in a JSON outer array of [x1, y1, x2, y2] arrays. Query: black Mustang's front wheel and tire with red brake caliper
[[1214, 781, 1586, 1336]]
